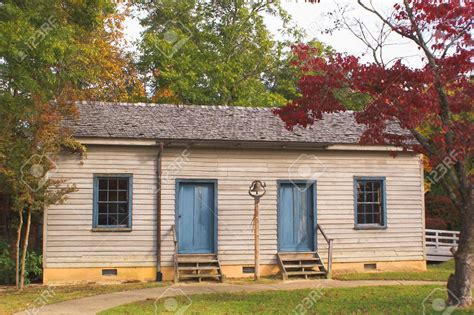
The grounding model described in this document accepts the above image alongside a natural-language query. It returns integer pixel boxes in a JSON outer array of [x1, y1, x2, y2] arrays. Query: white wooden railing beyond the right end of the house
[[425, 229, 460, 261]]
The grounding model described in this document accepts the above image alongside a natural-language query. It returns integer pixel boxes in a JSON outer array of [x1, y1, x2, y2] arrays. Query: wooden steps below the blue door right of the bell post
[[278, 252, 328, 280]]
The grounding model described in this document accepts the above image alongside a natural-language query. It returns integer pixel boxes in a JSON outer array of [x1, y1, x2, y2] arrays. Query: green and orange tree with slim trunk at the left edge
[[0, 0, 139, 289]]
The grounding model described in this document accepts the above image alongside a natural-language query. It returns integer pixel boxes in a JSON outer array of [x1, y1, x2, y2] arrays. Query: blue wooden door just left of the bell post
[[176, 182, 216, 254]]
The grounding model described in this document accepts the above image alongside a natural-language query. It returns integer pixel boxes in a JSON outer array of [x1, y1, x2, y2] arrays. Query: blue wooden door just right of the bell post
[[278, 183, 315, 252]]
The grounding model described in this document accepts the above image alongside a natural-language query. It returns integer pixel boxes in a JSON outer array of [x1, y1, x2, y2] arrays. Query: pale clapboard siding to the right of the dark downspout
[[161, 149, 424, 266]]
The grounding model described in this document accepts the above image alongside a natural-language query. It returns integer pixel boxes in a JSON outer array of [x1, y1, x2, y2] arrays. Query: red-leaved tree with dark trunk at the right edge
[[275, 0, 474, 306]]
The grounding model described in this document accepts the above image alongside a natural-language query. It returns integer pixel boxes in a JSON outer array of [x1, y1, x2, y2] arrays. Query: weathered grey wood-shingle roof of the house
[[66, 102, 405, 144]]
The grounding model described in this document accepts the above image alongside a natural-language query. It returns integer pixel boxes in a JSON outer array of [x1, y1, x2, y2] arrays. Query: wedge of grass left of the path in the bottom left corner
[[0, 282, 166, 315]]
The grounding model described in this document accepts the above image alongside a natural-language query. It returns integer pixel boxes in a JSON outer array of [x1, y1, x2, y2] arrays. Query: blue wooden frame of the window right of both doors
[[354, 176, 388, 230]]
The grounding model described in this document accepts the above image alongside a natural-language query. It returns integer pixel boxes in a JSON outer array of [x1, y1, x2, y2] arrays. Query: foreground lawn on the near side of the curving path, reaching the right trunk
[[100, 285, 474, 315]]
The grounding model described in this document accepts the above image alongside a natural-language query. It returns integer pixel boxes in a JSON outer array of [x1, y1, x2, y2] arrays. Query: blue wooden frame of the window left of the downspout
[[92, 173, 133, 231]]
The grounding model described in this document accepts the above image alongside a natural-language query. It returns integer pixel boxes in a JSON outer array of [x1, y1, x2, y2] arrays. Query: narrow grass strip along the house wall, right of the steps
[[333, 260, 454, 281]]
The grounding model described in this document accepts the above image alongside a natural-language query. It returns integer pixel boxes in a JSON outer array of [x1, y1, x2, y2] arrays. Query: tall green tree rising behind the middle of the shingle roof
[[139, 0, 301, 106]]
